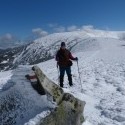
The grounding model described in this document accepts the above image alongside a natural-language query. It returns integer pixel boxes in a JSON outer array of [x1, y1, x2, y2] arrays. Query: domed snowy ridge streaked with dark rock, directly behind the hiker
[[14, 29, 125, 64]]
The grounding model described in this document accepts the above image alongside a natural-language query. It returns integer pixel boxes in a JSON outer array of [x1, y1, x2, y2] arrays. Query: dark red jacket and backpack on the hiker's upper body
[[56, 48, 75, 67]]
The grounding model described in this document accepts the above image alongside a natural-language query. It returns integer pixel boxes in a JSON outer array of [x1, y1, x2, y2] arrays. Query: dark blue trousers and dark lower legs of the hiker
[[59, 66, 72, 87]]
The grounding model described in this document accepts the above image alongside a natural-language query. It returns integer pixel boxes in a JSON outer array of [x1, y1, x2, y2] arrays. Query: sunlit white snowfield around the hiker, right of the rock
[[38, 38, 125, 125]]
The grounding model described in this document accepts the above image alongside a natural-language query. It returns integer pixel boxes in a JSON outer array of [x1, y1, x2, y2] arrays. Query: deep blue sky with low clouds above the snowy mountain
[[0, 0, 125, 42]]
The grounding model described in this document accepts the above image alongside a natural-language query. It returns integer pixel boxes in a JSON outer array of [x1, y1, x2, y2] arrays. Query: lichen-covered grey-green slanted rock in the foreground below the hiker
[[33, 66, 85, 125]]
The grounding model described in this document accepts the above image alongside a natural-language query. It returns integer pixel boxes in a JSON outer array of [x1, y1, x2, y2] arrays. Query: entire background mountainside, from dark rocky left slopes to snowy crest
[[0, 29, 125, 71]]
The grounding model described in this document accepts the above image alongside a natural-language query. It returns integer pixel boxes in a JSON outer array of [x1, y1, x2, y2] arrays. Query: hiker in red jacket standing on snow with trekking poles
[[56, 42, 78, 87]]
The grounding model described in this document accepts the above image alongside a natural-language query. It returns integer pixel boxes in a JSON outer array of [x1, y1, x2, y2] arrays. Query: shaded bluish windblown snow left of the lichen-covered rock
[[0, 66, 54, 125]]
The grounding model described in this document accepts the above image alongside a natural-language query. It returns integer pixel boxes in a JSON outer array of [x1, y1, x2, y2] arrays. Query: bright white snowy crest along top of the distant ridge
[[35, 29, 125, 46]]
